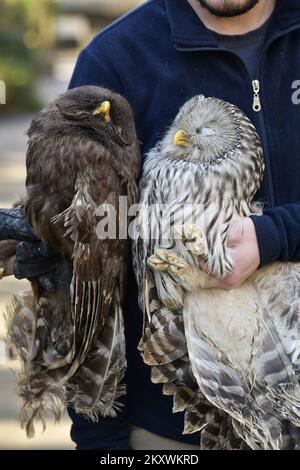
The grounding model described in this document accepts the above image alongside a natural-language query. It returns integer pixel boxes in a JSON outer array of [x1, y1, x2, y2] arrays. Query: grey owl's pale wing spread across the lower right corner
[[184, 286, 300, 449]]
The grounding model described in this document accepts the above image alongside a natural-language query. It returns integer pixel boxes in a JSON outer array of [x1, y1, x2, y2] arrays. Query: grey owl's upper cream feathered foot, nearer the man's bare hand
[[174, 224, 208, 261]]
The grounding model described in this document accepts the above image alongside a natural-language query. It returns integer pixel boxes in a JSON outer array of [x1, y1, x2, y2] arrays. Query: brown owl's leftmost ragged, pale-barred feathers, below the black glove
[[5, 290, 66, 438]]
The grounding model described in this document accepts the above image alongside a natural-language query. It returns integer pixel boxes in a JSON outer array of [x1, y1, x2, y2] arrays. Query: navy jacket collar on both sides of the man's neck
[[164, 0, 300, 49]]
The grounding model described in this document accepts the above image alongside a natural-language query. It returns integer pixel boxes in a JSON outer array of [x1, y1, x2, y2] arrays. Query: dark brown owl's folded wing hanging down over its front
[[53, 171, 122, 380]]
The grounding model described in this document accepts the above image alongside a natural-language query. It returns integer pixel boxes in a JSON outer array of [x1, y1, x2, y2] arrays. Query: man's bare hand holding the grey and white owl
[[204, 217, 260, 290]]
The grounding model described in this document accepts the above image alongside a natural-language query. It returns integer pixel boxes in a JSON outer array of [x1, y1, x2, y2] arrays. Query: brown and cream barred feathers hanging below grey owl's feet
[[139, 300, 216, 434]]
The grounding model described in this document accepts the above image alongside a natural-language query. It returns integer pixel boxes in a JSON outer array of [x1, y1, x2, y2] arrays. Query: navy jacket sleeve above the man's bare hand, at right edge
[[251, 201, 300, 267]]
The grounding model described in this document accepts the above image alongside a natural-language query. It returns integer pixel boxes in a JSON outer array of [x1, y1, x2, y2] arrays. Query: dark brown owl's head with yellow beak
[[28, 86, 136, 146]]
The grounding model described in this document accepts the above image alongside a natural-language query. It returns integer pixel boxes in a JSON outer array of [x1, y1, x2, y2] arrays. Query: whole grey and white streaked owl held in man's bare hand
[[133, 96, 300, 449]]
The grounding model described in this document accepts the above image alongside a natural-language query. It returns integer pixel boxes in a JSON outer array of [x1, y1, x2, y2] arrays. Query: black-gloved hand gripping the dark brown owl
[[0, 209, 72, 292]]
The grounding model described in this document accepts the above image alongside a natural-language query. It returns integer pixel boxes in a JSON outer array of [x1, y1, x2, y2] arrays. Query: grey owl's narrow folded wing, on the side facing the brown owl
[[132, 170, 211, 433]]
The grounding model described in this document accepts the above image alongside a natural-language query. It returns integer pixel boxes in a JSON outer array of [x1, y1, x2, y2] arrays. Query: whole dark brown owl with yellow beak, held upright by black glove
[[4, 86, 140, 434]]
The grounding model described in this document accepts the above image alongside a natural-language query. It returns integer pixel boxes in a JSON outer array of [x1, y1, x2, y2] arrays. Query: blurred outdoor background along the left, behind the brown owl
[[0, 0, 142, 449]]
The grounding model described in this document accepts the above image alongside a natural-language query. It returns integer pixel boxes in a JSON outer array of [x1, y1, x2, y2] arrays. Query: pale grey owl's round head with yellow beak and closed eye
[[161, 95, 257, 167]]
